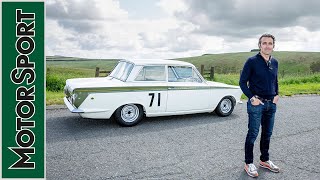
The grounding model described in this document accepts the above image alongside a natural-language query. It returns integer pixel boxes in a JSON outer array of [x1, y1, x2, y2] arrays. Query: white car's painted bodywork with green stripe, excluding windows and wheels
[[64, 60, 242, 119]]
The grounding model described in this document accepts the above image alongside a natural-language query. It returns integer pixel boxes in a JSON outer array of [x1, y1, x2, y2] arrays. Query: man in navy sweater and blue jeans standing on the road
[[239, 34, 280, 177]]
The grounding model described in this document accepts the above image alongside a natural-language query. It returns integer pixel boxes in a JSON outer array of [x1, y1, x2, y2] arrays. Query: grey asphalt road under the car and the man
[[46, 96, 320, 180]]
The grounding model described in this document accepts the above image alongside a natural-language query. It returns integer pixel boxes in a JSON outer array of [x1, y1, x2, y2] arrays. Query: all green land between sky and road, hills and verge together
[[46, 52, 320, 105]]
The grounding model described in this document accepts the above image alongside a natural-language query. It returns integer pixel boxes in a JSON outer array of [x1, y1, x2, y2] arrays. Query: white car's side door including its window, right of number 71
[[166, 66, 210, 113]]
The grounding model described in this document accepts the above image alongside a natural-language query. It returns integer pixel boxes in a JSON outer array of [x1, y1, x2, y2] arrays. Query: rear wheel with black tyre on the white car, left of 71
[[114, 104, 143, 126]]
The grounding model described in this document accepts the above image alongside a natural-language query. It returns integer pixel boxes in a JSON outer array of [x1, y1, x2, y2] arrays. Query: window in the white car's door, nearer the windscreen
[[168, 66, 202, 83]]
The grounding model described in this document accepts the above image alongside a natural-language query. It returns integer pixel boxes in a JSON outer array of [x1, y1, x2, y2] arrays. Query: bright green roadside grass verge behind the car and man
[[46, 67, 320, 105]]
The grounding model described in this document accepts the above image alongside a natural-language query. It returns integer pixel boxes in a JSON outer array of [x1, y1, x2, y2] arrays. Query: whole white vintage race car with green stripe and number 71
[[64, 59, 242, 126]]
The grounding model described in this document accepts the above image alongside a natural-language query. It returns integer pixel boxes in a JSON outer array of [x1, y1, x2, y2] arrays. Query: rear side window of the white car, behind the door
[[135, 66, 166, 81]]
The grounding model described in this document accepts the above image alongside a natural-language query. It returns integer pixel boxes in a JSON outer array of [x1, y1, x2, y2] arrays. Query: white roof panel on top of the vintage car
[[121, 59, 194, 66]]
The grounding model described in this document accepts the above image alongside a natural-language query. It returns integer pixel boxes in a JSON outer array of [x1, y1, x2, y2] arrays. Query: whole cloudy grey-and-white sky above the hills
[[46, 0, 320, 58]]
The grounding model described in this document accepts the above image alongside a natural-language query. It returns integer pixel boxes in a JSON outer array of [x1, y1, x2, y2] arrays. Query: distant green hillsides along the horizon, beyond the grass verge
[[47, 51, 320, 74]]
